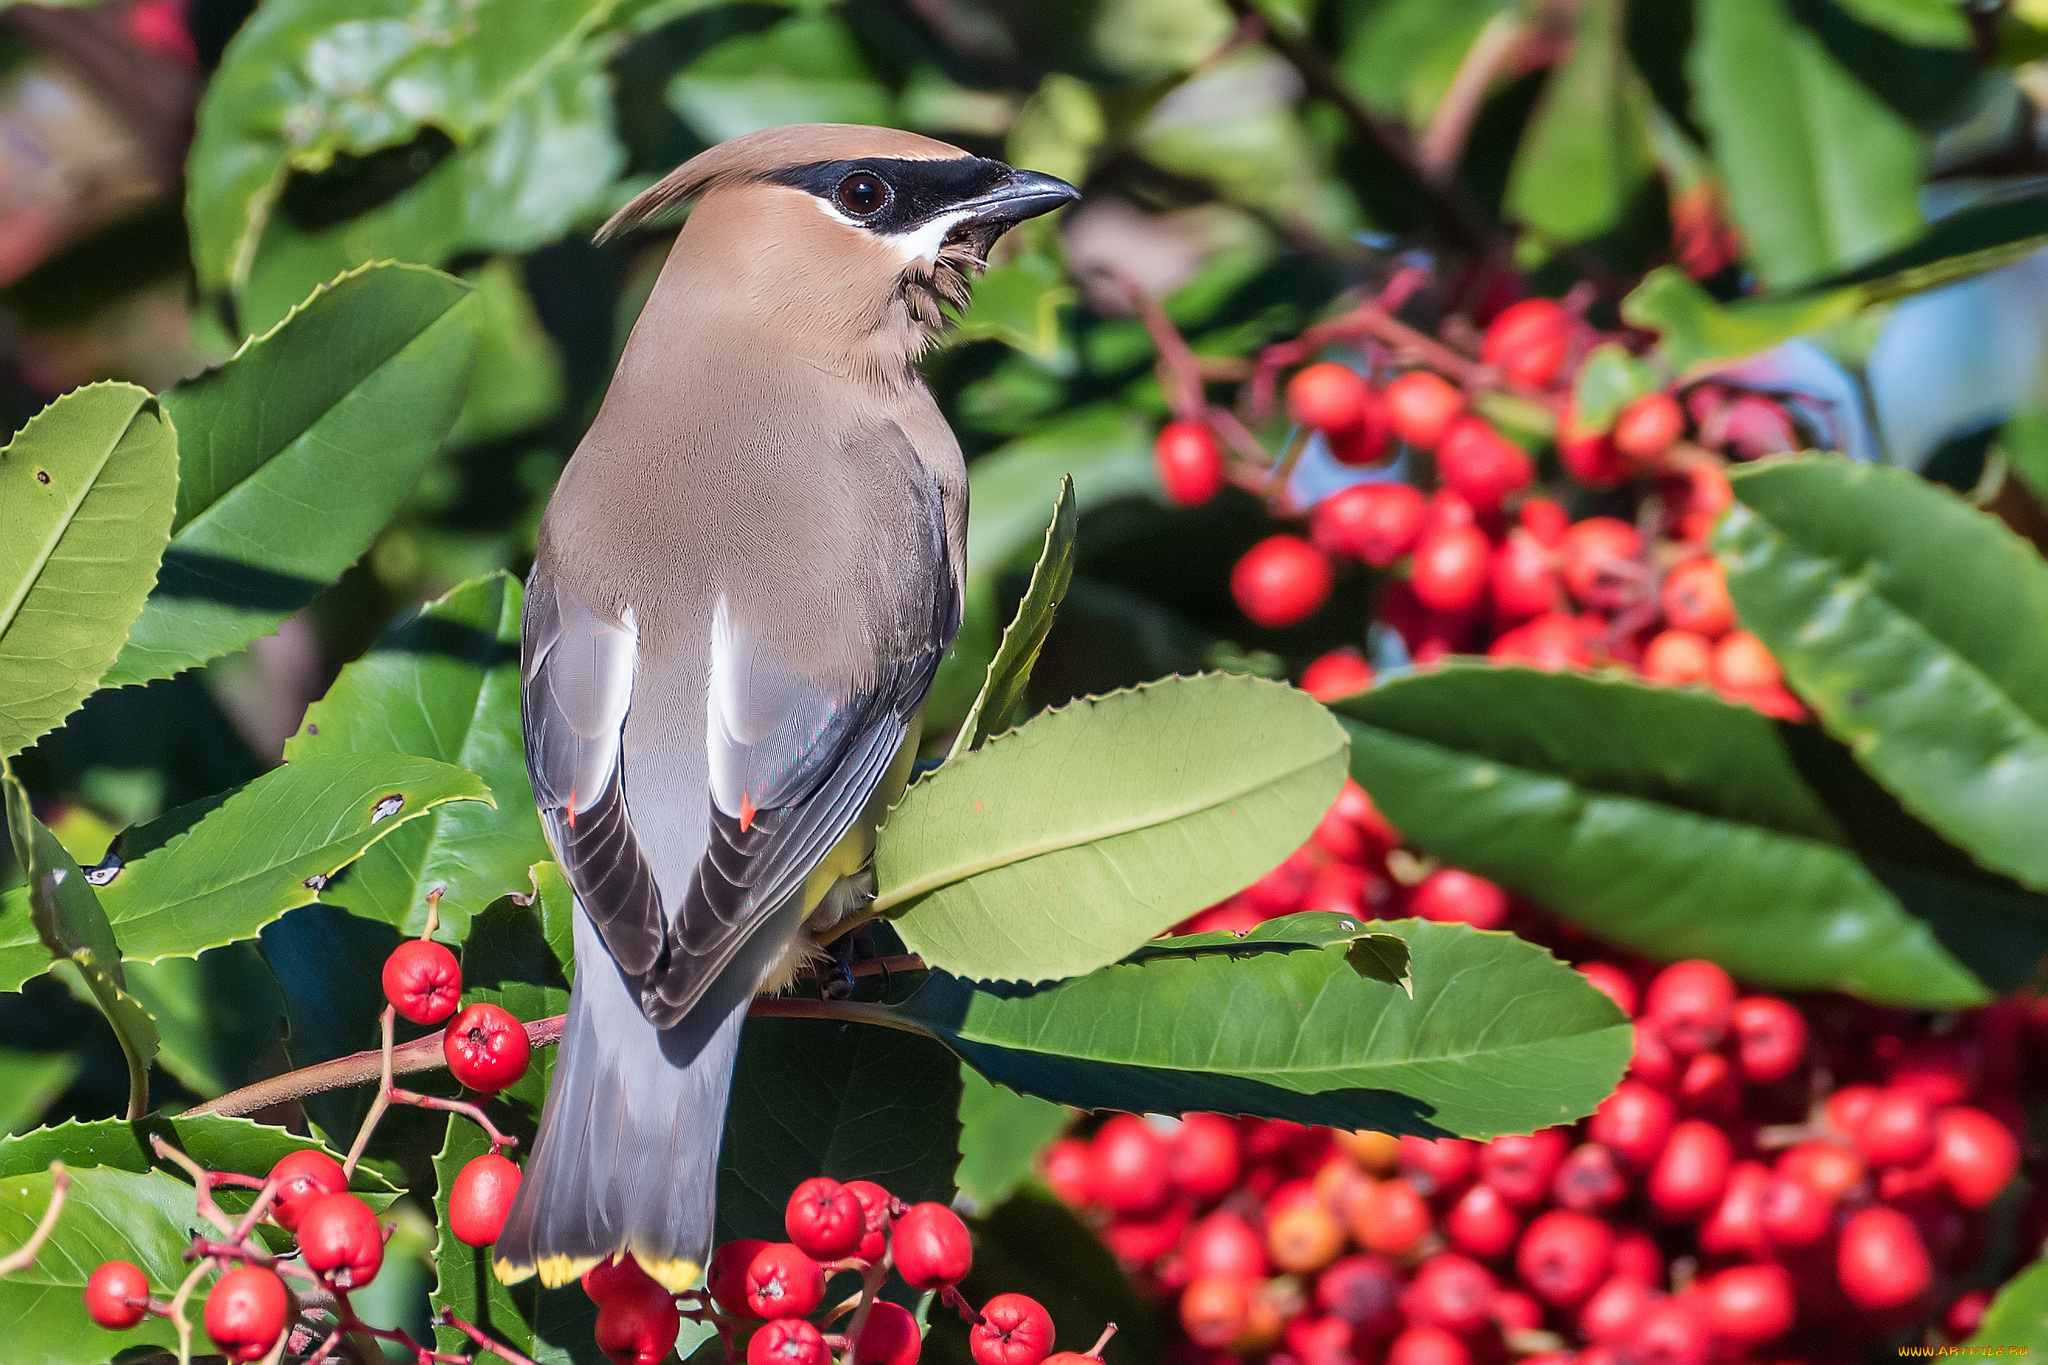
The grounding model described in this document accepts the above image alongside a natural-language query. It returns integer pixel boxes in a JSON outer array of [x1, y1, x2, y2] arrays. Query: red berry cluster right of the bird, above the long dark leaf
[[1155, 288, 1802, 718]]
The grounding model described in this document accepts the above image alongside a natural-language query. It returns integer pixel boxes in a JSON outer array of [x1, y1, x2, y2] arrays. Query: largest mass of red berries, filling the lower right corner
[[1044, 786, 2048, 1365]]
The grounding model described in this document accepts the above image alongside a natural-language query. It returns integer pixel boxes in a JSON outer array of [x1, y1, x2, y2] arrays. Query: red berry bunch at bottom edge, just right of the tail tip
[[584, 1177, 1100, 1365]]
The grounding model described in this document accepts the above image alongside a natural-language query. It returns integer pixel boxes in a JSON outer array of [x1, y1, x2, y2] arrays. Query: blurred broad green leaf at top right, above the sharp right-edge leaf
[[1686, 0, 1925, 289]]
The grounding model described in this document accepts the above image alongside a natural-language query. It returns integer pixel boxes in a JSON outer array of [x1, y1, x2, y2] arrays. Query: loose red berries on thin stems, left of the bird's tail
[[86, 939, 528, 1361]]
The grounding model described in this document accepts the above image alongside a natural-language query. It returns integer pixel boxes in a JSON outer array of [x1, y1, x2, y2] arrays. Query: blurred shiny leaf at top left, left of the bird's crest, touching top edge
[[186, 0, 616, 293]]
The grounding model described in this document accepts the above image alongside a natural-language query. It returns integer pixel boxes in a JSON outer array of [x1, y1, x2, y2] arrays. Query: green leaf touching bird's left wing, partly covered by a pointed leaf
[[285, 573, 549, 943]]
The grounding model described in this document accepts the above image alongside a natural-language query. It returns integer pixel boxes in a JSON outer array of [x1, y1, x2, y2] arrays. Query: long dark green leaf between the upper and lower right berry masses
[[1339, 665, 2048, 1005]]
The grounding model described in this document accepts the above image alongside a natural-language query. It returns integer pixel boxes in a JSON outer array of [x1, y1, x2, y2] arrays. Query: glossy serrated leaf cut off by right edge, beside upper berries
[[1716, 456, 2048, 890]]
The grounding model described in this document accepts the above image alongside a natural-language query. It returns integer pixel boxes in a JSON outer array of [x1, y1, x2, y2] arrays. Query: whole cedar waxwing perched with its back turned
[[496, 125, 1077, 1289]]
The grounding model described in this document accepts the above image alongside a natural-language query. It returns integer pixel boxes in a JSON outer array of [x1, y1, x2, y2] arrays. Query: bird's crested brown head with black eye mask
[[598, 123, 1079, 370]]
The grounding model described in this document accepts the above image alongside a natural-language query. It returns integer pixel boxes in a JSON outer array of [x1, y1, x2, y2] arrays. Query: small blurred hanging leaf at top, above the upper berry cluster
[[1505, 0, 1646, 241]]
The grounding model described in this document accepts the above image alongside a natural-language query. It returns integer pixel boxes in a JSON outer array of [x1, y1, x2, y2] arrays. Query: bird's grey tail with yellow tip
[[494, 907, 756, 1291]]
